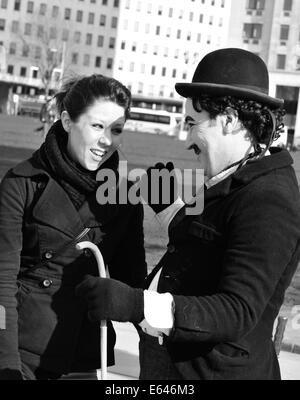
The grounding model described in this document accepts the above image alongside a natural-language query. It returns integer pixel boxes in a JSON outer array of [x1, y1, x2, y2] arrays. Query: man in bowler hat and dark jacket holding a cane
[[77, 48, 300, 380]]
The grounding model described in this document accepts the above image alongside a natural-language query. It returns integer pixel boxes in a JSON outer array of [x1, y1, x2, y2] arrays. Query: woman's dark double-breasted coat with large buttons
[[0, 159, 146, 373]]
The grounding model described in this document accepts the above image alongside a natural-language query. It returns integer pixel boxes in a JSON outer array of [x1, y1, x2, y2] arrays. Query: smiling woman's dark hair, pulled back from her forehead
[[54, 74, 131, 122]]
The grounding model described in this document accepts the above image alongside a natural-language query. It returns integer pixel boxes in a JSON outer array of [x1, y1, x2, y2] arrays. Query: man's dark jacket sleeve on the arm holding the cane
[[170, 187, 300, 342]]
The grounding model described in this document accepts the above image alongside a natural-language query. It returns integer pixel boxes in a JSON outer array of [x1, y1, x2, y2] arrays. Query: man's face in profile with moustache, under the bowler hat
[[186, 98, 251, 178]]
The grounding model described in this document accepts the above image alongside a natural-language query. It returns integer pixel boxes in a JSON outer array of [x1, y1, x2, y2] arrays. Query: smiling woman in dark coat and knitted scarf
[[0, 75, 146, 379]]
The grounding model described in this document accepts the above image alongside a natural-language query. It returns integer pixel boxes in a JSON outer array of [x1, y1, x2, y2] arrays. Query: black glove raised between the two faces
[[147, 162, 177, 214]]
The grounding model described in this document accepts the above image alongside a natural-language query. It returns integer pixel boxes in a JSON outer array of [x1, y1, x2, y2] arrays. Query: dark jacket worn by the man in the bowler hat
[[148, 149, 300, 379]]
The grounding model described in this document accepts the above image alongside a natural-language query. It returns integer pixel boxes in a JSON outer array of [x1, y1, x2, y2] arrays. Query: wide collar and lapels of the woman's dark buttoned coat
[[12, 159, 117, 237]]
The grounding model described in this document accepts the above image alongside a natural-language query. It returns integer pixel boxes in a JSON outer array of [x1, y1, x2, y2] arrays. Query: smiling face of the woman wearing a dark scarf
[[61, 100, 125, 171]]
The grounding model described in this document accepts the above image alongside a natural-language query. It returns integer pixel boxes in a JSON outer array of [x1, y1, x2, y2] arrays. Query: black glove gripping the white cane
[[76, 275, 144, 323]]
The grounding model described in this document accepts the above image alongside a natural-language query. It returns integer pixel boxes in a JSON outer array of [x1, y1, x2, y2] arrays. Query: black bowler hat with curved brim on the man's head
[[175, 48, 284, 108]]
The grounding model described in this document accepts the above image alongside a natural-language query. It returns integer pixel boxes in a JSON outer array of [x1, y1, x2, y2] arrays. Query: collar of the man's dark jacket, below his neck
[[204, 147, 293, 202]]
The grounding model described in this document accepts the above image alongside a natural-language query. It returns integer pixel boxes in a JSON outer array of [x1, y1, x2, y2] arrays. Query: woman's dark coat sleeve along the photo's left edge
[[0, 173, 25, 370]]
